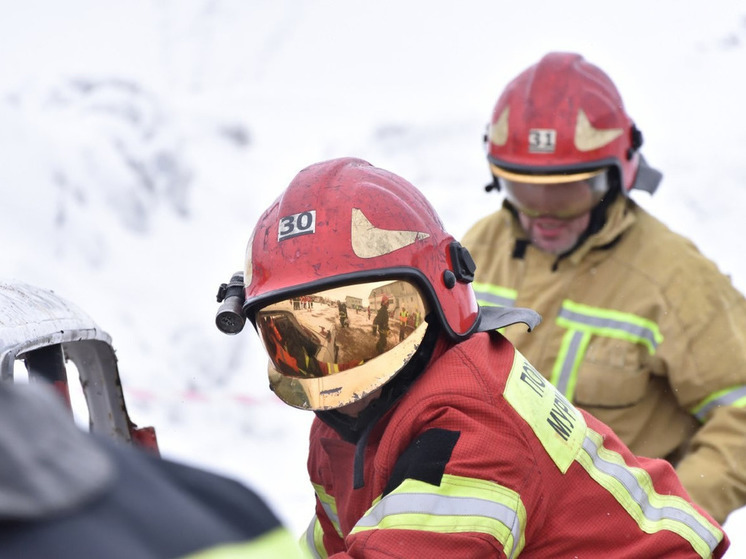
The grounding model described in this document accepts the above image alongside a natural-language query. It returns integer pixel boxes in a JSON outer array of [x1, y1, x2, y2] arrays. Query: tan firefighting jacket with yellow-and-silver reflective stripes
[[463, 197, 746, 522]]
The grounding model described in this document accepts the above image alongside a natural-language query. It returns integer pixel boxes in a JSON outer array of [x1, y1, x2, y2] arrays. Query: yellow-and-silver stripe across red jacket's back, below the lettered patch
[[577, 429, 723, 557]]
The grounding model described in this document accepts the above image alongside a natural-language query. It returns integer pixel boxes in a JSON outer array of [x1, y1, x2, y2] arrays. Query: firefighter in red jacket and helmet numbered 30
[[227, 158, 728, 558]]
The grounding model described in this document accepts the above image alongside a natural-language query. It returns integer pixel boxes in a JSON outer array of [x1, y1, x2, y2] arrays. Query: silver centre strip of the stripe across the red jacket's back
[[583, 437, 719, 551]]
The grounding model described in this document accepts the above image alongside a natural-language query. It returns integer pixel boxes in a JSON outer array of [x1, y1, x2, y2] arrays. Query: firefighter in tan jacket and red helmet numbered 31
[[463, 52, 746, 522]]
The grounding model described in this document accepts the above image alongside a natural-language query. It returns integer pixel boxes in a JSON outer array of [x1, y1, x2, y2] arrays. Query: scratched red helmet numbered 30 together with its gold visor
[[244, 158, 479, 409]]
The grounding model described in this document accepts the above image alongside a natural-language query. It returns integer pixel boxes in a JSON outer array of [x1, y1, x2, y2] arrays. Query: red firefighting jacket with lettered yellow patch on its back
[[305, 332, 729, 559]]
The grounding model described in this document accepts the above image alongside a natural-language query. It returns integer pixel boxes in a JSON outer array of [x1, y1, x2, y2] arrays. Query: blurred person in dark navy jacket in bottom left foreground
[[0, 382, 300, 559]]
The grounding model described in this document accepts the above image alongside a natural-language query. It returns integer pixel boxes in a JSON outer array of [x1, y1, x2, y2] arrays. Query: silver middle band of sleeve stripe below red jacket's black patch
[[355, 493, 521, 557]]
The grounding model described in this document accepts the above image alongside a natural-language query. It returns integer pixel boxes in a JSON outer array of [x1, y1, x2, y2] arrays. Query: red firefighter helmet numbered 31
[[486, 52, 662, 193]]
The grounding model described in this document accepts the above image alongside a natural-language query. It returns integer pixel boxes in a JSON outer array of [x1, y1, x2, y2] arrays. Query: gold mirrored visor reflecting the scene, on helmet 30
[[255, 280, 428, 410]]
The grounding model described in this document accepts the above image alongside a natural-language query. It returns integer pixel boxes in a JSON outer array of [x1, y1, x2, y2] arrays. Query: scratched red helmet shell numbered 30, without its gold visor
[[244, 158, 478, 340]]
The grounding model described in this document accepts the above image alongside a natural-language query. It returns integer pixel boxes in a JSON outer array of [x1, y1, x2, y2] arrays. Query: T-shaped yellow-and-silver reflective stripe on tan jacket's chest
[[550, 299, 663, 400]]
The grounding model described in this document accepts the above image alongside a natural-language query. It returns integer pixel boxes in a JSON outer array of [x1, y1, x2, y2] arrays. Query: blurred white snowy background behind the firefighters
[[0, 0, 746, 557]]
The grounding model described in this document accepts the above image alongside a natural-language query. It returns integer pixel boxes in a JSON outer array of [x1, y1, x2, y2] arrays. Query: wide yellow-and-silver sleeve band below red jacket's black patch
[[350, 474, 526, 557]]
